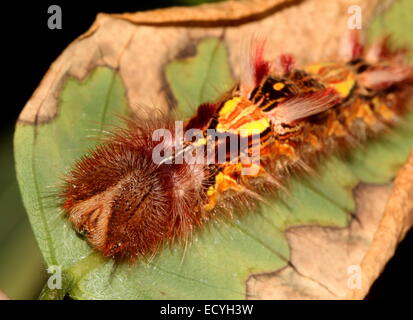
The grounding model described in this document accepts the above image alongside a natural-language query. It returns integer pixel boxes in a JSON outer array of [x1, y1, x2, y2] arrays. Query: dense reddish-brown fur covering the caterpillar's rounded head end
[[62, 120, 205, 261]]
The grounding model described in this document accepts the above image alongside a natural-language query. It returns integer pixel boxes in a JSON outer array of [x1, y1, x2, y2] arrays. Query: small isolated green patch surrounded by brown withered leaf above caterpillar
[[165, 38, 234, 118]]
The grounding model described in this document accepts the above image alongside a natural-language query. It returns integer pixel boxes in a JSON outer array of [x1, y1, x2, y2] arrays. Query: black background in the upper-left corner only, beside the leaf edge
[[1, 0, 191, 124]]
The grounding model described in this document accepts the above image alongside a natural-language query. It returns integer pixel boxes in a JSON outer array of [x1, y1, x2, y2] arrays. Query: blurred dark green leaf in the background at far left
[[0, 127, 45, 300]]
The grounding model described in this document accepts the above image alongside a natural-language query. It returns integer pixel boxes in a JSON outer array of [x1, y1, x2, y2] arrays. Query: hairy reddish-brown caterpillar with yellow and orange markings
[[59, 32, 413, 262]]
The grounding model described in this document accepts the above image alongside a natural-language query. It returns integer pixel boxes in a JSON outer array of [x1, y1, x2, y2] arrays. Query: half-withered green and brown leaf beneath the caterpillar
[[15, 0, 413, 299]]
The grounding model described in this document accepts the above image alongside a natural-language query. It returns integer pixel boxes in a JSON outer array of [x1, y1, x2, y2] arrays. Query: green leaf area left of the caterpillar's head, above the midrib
[[14, 67, 128, 269]]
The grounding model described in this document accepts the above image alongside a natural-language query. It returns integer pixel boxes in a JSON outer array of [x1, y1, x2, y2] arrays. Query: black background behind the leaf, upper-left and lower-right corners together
[[0, 0, 413, 299]]
